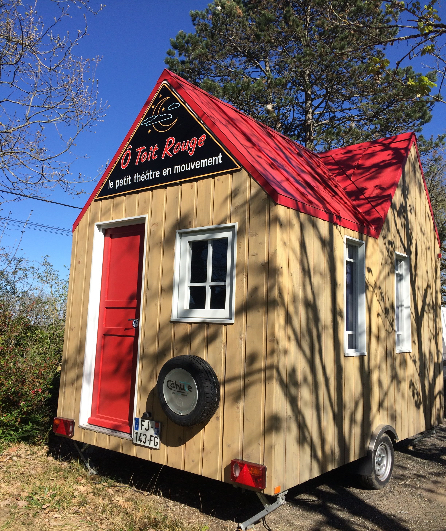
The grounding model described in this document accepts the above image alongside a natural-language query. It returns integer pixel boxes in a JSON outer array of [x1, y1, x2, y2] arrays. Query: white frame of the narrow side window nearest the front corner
[[344, 236, 367, 356]]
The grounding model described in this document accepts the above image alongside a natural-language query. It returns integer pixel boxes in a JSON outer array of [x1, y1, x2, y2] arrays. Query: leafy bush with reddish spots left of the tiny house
[[0, 253, 66, 442]]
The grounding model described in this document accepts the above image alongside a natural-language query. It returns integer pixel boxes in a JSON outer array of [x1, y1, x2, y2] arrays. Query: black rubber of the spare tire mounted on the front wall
[[156, 356, 220, 426]]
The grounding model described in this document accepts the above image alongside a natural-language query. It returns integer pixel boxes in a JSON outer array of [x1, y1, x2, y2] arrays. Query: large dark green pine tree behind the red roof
[[165, 0, 435, 149]]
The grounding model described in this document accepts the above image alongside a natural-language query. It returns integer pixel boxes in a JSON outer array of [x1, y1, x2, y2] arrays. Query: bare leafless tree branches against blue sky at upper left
[[0, 0, 104, 197]]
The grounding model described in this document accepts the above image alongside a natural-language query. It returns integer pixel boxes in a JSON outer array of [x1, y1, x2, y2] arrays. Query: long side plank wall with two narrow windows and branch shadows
[[273, 143, 443, 488]]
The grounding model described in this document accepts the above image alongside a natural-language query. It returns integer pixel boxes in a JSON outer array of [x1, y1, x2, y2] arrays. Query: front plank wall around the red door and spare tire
[[58, 171, 286, 494]]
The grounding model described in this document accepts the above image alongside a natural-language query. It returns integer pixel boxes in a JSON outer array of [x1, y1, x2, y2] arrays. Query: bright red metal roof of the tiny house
[[73, 70, 440, 244]]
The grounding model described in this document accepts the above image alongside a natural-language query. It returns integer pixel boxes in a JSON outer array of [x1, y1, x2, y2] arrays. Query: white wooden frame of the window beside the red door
[[171, 223, 237, 323]]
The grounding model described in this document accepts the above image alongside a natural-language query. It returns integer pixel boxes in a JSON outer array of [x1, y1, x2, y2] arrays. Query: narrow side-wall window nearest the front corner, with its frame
[[344, 238, 366, 356]]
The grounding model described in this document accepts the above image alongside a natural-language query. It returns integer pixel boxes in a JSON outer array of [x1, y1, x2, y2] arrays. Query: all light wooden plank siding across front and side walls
[[58, 144, 443, 494]]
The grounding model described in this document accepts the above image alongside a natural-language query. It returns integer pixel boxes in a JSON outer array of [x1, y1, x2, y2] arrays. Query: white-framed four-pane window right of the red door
[[172, 224, 237, 323]]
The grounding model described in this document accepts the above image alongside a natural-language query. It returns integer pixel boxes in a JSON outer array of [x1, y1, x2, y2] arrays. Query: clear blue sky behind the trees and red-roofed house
[[0, 0, 446, 276]]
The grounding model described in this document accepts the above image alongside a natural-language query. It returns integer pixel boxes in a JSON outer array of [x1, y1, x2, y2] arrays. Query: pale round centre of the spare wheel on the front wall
[[163, 368, 198, 415]]
